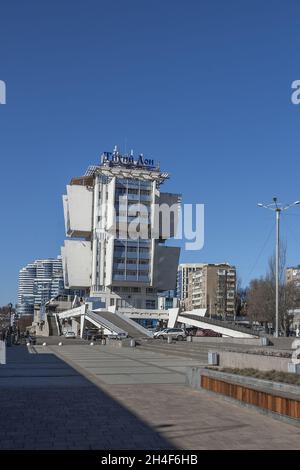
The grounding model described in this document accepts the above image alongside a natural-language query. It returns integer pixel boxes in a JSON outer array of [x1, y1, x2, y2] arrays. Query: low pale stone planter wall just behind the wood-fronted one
[[216, 351, 291, 372]]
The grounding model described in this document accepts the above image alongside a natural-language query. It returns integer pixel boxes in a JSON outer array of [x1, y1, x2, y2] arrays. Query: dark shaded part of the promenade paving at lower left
[[0, 346, 172, 449]]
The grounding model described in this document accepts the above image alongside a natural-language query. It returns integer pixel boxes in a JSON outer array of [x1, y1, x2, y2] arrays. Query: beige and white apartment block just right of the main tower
[[185, 263, 236, 315]]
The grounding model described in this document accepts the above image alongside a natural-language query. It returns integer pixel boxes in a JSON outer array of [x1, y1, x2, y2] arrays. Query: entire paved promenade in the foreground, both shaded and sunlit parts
[[0, 344, 300, 449]]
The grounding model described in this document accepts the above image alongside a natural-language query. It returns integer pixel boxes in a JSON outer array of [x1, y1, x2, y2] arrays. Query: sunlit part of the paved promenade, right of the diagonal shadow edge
[[51, 346, 300, 450]]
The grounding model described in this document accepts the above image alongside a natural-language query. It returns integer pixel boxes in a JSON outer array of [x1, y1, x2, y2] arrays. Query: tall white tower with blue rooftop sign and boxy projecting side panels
[[62, 148, 180, 309]]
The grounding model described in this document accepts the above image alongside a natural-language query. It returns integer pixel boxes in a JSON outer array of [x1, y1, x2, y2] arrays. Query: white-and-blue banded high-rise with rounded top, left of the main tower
[[17, 256, 82, 315]]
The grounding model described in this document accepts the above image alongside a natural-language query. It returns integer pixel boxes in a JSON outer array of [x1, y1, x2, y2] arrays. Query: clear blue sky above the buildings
[[0, 0, 300, 305]]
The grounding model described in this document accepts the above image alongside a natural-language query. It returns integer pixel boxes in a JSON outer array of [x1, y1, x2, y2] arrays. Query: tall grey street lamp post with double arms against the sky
[[257, 197, 300, 338]]
